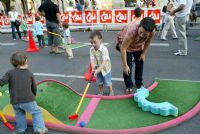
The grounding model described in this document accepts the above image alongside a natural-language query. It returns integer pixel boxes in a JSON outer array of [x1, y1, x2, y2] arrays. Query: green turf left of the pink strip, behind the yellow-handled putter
[[36, 82, 91, 125]]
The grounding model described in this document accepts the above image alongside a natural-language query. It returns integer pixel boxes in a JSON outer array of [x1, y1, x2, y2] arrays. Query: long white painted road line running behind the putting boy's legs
[[34, 73, 124, 81]]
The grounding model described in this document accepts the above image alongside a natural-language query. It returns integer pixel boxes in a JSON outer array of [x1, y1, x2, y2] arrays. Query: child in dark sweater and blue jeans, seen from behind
[[0, 52, 48, 134]]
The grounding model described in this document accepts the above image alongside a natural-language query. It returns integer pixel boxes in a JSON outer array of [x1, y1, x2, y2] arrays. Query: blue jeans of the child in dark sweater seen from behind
[[13, 101, 45, 132]]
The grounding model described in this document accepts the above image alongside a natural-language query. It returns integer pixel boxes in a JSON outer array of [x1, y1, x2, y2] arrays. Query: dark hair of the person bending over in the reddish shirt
[[139, 17, 156, 32]]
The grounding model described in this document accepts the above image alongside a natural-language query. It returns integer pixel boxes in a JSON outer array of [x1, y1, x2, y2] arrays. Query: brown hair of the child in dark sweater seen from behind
[[10, 52, 27, 67]]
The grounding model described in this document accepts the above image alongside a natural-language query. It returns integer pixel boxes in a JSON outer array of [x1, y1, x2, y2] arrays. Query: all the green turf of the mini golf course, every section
[[0, 80, 200, 130]]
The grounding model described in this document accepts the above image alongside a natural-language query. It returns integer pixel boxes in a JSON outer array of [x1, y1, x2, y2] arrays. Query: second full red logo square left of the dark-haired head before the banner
[[99, 10, 112, 23]]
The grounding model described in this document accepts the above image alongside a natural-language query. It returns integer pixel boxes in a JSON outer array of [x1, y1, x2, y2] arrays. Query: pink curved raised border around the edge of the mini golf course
[[3, 80, 200, 134]]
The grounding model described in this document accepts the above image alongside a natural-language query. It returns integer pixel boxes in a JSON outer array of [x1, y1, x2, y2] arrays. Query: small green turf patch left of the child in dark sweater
[[0, 85, 10, 111]]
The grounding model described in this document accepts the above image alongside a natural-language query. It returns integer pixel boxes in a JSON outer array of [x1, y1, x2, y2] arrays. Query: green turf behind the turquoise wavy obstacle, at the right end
[[148, 80, 200, 115]]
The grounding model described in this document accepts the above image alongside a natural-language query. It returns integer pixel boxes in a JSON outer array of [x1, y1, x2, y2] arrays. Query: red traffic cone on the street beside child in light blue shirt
[[26, 30, 39, 52]]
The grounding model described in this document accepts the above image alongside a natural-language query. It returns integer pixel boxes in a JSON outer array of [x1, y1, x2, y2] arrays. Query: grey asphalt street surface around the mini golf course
[[0, 29, 200, 134]]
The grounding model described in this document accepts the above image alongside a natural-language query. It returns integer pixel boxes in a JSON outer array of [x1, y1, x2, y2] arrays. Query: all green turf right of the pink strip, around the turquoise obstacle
[[87, 80, 200, 130]]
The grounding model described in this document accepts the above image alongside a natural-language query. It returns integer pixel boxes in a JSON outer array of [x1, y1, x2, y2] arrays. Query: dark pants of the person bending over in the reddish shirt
[[123, 51, 144, 88]]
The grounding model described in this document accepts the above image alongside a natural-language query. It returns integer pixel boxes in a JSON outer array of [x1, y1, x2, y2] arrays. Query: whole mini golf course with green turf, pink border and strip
[[0, 80, 200, 134]]
